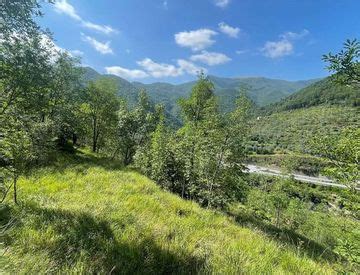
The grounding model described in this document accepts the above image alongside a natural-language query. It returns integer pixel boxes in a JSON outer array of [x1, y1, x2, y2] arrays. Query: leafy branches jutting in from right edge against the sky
[[323, 39, 360, 85]]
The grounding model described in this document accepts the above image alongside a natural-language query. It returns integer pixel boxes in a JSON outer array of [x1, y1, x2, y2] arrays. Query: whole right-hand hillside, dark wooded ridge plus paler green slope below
[[249, 78, 360, 154]]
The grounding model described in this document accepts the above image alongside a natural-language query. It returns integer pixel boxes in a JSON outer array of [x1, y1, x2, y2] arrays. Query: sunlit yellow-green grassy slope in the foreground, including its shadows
[[0, 152, 333, 274]]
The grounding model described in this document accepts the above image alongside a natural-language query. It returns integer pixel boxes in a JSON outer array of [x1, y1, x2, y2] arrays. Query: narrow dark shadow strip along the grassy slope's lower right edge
[[227, 212, 339, 262]]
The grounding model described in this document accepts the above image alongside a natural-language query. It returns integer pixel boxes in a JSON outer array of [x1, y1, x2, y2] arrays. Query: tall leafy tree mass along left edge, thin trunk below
[[0, 1, 83, 201]]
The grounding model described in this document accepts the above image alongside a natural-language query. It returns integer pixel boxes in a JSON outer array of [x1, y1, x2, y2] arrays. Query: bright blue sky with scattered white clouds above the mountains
[[40, 0, 360, 83]]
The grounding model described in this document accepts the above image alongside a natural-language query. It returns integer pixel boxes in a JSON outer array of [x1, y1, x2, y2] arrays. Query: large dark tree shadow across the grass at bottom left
[[0, 204, 205, 274]]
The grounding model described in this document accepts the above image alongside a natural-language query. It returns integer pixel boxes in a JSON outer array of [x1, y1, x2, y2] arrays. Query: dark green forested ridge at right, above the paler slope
[[264, 78, 360, 113]]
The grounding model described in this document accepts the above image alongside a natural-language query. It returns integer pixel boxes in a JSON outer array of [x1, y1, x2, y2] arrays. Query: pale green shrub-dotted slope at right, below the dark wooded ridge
[[248, 106, 360, 154]]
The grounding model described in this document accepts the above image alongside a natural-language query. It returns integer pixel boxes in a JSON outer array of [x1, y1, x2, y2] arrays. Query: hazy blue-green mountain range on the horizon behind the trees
[[84, 67, 318, 118]]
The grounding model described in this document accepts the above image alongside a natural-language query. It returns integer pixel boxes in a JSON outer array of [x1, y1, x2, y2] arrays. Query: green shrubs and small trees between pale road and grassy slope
[[236, 176, 360, 273]]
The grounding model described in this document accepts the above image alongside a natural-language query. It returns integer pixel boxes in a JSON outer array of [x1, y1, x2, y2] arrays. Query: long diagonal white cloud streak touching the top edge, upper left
[[54, 0, 118, 34]]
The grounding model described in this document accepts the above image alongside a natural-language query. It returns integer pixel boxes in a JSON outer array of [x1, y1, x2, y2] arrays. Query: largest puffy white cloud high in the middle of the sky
[[175, 29, 217, 51]]
